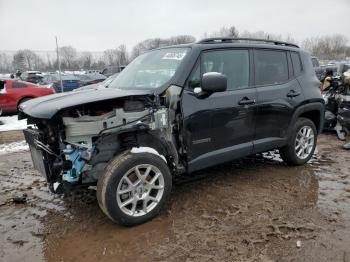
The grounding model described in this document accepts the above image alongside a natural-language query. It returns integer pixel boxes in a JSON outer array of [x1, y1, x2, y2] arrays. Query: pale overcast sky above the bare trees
[[0, 0, 350, 51]]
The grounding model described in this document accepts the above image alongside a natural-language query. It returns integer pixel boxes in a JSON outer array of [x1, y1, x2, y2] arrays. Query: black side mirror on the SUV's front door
[[202, 72, 227, 93]]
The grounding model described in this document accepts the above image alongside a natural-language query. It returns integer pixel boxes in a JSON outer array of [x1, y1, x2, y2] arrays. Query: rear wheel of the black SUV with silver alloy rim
[[279, 117, 317, 166]]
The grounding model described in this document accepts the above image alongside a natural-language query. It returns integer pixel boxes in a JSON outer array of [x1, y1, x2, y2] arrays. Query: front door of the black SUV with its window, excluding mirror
[[181, 49, 257, 172]]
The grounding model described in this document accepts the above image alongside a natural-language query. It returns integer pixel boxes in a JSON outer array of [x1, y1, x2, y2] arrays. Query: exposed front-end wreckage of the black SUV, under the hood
[[22, 86, 184, 192]]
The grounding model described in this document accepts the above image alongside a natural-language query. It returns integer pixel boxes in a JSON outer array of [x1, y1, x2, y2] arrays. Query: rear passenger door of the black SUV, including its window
[[254, 49, 303, 153]]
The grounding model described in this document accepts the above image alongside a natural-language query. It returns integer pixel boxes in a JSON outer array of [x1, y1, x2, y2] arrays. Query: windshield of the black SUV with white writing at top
[[109, 48, 190, 89]]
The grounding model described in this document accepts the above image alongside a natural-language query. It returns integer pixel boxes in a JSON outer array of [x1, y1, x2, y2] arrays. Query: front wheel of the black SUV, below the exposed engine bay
[[97, 151, 172, 226]]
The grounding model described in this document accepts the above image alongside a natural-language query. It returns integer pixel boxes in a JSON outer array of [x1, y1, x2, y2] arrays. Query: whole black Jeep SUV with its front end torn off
[[19, 38, 324, 225]]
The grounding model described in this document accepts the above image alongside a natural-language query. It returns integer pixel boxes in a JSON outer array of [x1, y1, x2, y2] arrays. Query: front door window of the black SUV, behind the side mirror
[[201, 49, 249, 90]]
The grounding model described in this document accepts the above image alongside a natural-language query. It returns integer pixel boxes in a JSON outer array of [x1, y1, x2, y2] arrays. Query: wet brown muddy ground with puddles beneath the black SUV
[[0, 134, 350, 262]]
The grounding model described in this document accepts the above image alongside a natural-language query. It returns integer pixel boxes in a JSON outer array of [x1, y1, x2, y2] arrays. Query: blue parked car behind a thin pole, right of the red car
[[40, 74, 82, 93]]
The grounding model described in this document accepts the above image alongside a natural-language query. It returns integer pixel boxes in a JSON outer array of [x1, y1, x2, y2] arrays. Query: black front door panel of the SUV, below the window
[[182, 88, 256, 172]]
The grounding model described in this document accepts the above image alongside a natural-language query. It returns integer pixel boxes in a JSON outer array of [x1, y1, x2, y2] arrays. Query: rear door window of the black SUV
[[254, 50, 288, 85]]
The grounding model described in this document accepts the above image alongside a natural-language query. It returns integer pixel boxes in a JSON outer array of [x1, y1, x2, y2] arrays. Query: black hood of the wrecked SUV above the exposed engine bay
[[19, 88, 153, 119]]
